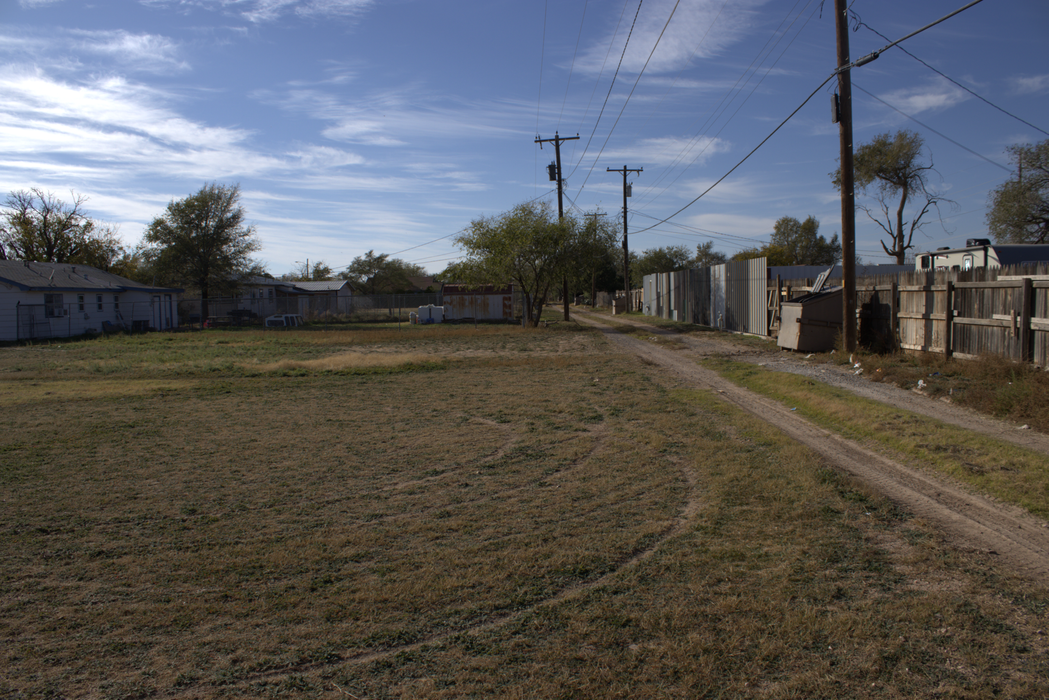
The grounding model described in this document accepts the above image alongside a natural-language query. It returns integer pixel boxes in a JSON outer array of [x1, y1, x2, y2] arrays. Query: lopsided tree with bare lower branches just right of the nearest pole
[[831, 129, 949, 264]]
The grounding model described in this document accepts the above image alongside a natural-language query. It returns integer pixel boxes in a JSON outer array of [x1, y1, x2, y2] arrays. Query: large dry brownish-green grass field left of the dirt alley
[[0, 323, 1049, 699]]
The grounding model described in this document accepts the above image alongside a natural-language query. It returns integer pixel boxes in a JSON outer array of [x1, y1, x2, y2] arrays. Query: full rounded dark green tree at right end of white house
[[143, 183, 263, 320]]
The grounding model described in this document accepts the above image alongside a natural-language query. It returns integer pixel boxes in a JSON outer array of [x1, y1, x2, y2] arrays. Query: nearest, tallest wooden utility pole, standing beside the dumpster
[[834, 0, 859, 353]]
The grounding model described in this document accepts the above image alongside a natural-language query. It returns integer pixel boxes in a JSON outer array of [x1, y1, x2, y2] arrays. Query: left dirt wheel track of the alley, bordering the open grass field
[[576, 314, 1049, 579]]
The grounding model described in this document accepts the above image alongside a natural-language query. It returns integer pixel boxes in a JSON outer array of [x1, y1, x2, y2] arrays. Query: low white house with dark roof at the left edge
[[0, 260, 181, 341]]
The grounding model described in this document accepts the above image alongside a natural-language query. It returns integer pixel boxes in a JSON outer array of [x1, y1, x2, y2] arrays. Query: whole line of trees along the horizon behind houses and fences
[[6, 130, 1049, 322]]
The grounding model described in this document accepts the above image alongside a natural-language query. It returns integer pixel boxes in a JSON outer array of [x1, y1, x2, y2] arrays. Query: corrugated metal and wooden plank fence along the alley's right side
[[644, 261, 1049, 368]]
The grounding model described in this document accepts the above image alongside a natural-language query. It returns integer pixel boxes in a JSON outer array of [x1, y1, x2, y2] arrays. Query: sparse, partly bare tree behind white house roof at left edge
[[0, 188, 132, 274]]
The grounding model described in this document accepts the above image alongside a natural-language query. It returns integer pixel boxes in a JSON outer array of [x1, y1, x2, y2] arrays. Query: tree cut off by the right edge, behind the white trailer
[[987, 140, 1049, 243]]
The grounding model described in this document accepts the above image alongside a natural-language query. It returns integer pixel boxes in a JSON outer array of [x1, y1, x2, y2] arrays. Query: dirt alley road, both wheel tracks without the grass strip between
[[573, 311, 1049, 580]]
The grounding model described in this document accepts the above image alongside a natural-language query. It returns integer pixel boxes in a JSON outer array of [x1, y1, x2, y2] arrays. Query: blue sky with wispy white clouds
[[0, 0, 1049, 275]]
